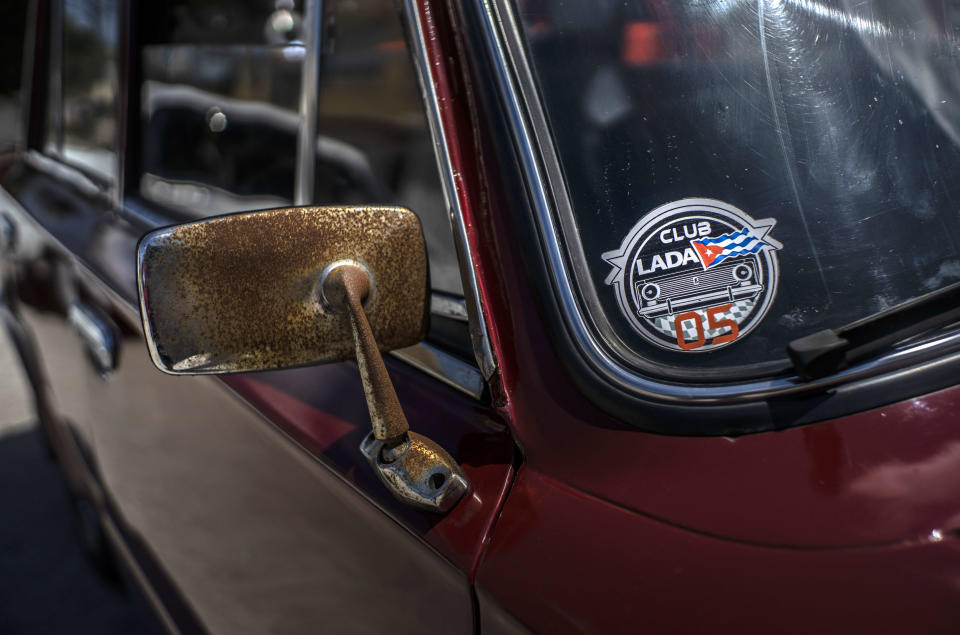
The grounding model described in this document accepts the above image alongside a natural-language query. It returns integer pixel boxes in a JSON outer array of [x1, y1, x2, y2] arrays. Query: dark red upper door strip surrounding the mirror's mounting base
[[223, 363, 513, 577]]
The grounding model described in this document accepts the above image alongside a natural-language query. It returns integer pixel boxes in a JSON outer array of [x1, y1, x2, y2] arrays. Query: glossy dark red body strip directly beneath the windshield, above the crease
[[513, 356, 960, 547]]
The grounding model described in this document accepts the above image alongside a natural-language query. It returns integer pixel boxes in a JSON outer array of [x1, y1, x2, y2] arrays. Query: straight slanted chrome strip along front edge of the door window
[[402, 0, 497, 379]]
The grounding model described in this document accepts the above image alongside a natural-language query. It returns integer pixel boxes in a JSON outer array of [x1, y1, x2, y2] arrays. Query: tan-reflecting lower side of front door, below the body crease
[[83, 328, 471, 632]]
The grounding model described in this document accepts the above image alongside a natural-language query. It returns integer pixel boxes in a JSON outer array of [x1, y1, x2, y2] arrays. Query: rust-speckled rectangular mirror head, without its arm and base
[[137, 207, 429, 374]]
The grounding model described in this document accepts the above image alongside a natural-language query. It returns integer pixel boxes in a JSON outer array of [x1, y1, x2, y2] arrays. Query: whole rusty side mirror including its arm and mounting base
[[137, 207, 469, 511]]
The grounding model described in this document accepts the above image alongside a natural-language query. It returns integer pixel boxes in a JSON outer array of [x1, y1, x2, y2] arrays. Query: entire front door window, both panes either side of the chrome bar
[[134, 0, 473, 359]]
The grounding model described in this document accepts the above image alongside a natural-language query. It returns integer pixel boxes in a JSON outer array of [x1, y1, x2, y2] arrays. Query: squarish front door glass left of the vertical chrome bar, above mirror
[[140, 0, 305, 216]]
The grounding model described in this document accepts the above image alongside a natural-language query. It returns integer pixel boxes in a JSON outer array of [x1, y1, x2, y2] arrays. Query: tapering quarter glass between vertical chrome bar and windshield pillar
[[316, 0, 463, 296]]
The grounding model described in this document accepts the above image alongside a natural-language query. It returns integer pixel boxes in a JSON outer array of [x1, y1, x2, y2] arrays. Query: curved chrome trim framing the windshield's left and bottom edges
[[478, 0, 960, 405]]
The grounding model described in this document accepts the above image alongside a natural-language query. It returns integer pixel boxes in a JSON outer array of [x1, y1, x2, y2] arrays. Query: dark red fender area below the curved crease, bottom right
[[478, 468, 960, 634]]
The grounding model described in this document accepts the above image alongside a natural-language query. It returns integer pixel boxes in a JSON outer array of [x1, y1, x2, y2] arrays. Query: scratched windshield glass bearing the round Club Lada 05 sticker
[[517, 0, 960, 378]]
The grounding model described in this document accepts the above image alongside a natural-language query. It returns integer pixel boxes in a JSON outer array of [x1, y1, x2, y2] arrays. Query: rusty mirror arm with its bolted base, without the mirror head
[[321, 264, 470, 513]]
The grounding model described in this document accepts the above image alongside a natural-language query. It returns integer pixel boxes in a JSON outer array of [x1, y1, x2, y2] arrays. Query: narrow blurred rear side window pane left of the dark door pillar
[[60, 0, 117, 178]]
